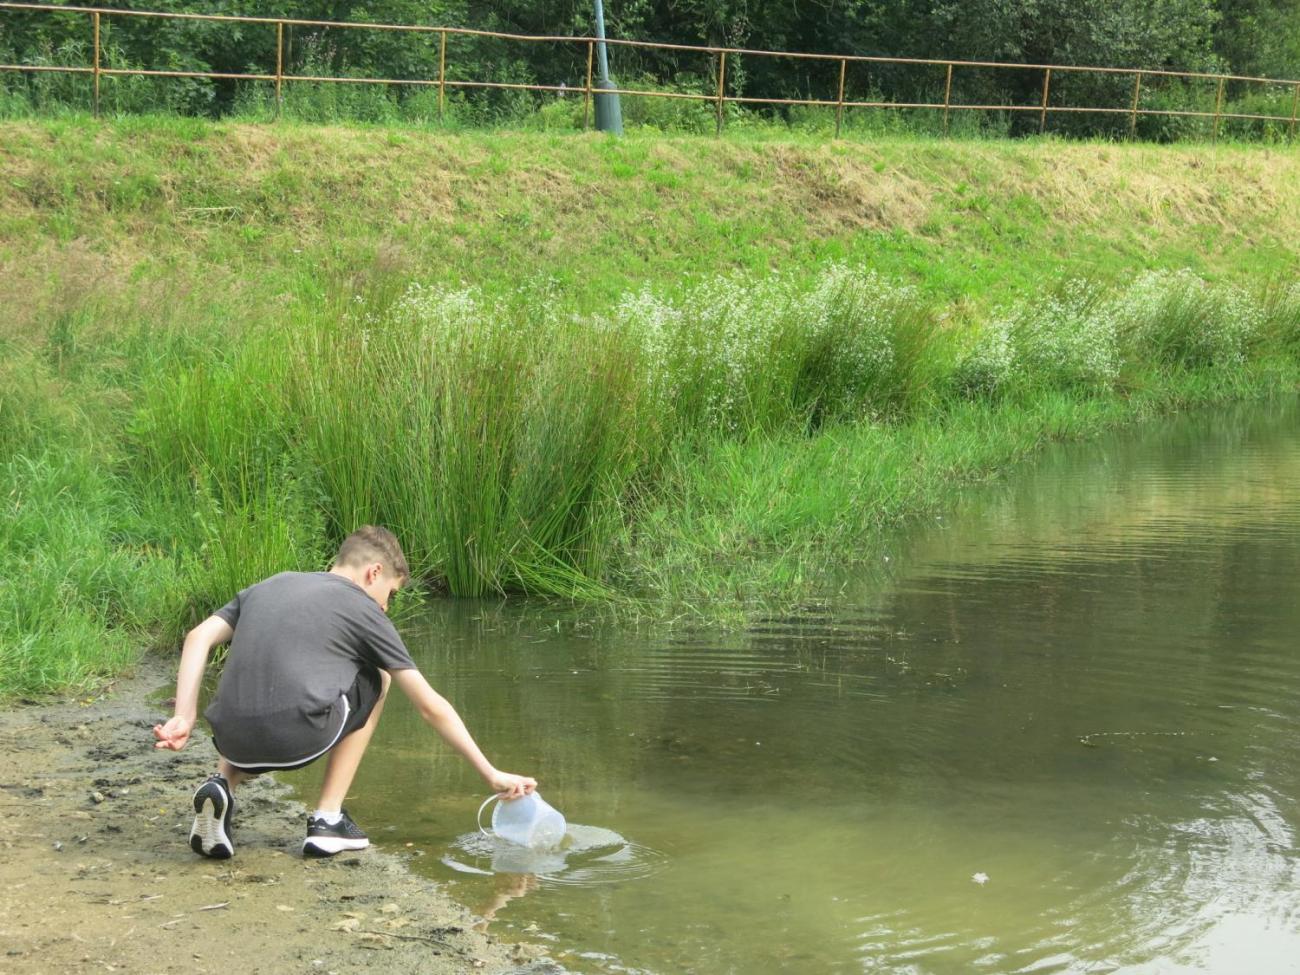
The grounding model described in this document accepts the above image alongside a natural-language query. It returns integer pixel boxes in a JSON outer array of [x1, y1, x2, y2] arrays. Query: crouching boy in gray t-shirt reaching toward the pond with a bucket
[[153, 525, 537, 859]]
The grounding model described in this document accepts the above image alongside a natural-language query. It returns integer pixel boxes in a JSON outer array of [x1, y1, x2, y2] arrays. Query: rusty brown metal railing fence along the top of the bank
[[0, 3, 1300, 140]]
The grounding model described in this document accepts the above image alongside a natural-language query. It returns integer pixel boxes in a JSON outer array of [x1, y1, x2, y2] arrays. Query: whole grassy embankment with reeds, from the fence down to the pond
[[0, 118, 1300, 697]]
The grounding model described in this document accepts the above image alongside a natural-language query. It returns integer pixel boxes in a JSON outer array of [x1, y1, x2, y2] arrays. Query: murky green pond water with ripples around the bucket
[[284, 403, 1300, 975]]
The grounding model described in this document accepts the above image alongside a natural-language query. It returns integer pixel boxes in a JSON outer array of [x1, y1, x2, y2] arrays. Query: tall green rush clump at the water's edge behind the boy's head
[[290, 286, 655, 595]]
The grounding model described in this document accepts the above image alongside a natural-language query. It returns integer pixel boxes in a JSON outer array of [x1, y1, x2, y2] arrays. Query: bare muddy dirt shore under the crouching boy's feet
[[0, 662, 562, 975]]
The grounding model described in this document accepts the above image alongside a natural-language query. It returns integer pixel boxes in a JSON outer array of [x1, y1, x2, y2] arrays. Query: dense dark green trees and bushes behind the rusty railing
[[0, 0, 1300, 138]]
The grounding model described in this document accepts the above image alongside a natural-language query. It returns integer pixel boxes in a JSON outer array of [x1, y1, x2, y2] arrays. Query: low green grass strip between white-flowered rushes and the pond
[[621, 359, 1300, 623]]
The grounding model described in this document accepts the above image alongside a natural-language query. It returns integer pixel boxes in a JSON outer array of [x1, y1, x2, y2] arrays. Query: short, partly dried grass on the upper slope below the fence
[[0, 117, 1300, 328]]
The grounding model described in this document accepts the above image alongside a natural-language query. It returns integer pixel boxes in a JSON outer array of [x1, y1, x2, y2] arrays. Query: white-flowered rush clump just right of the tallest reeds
[[610, 264, 957, 436]]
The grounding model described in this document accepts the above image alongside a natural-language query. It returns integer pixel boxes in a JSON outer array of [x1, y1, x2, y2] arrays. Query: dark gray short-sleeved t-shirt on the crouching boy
[[204, 572, 415, 766]]
